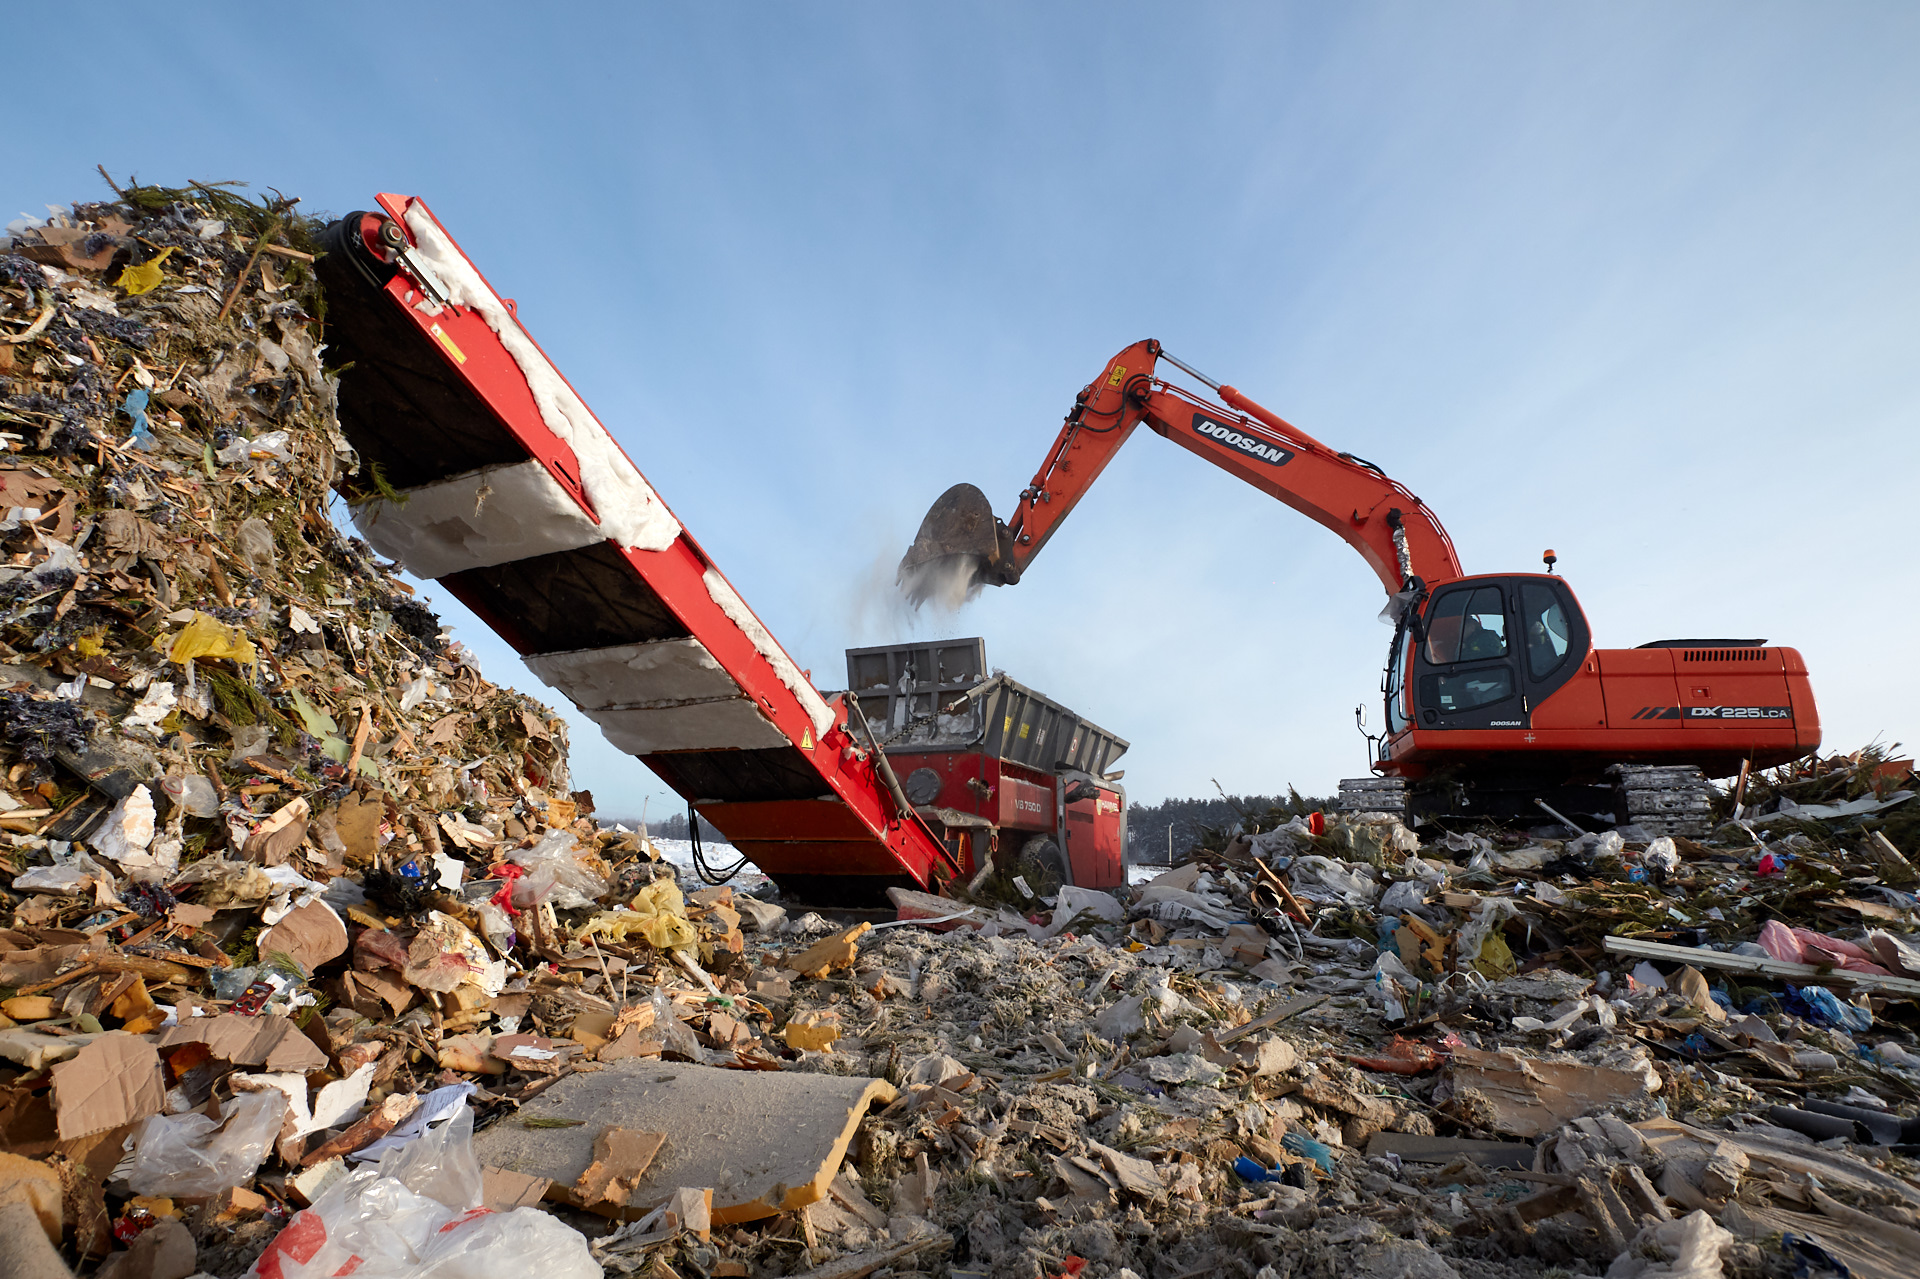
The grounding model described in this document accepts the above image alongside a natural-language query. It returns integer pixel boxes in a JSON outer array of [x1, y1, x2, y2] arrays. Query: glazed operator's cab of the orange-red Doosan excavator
[[1382, 574, 1592, 741]]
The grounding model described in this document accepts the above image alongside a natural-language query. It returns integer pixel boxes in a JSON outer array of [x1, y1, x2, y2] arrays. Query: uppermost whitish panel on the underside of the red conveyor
[[353, 461, 607, 578]]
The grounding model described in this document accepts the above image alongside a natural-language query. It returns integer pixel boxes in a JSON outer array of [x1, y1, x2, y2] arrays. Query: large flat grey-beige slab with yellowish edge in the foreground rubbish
[[474, 1058, 895, 1225]]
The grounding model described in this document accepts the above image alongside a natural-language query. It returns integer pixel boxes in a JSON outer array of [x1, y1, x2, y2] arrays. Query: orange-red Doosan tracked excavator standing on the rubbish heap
[[900, 340, 1820, 835]]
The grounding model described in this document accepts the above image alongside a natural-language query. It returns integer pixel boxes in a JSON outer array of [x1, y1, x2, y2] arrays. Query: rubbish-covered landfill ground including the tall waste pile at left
[[0, 186, 1920, 1279]]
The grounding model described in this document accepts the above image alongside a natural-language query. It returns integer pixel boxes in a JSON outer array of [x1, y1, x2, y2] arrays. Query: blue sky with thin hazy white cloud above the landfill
[[0, 4, 1920, 812]]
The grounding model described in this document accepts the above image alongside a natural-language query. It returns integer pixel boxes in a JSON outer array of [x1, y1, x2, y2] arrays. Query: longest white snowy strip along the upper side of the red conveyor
[[407, 202, 680, 563]]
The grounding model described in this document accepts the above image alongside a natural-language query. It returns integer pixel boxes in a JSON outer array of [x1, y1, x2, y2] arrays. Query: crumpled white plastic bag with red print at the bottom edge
[[248, 1100, 601, 1279]]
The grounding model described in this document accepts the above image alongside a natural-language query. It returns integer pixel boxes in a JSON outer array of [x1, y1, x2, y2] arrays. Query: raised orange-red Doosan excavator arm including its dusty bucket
[[900, 338, 1463, 603]]
